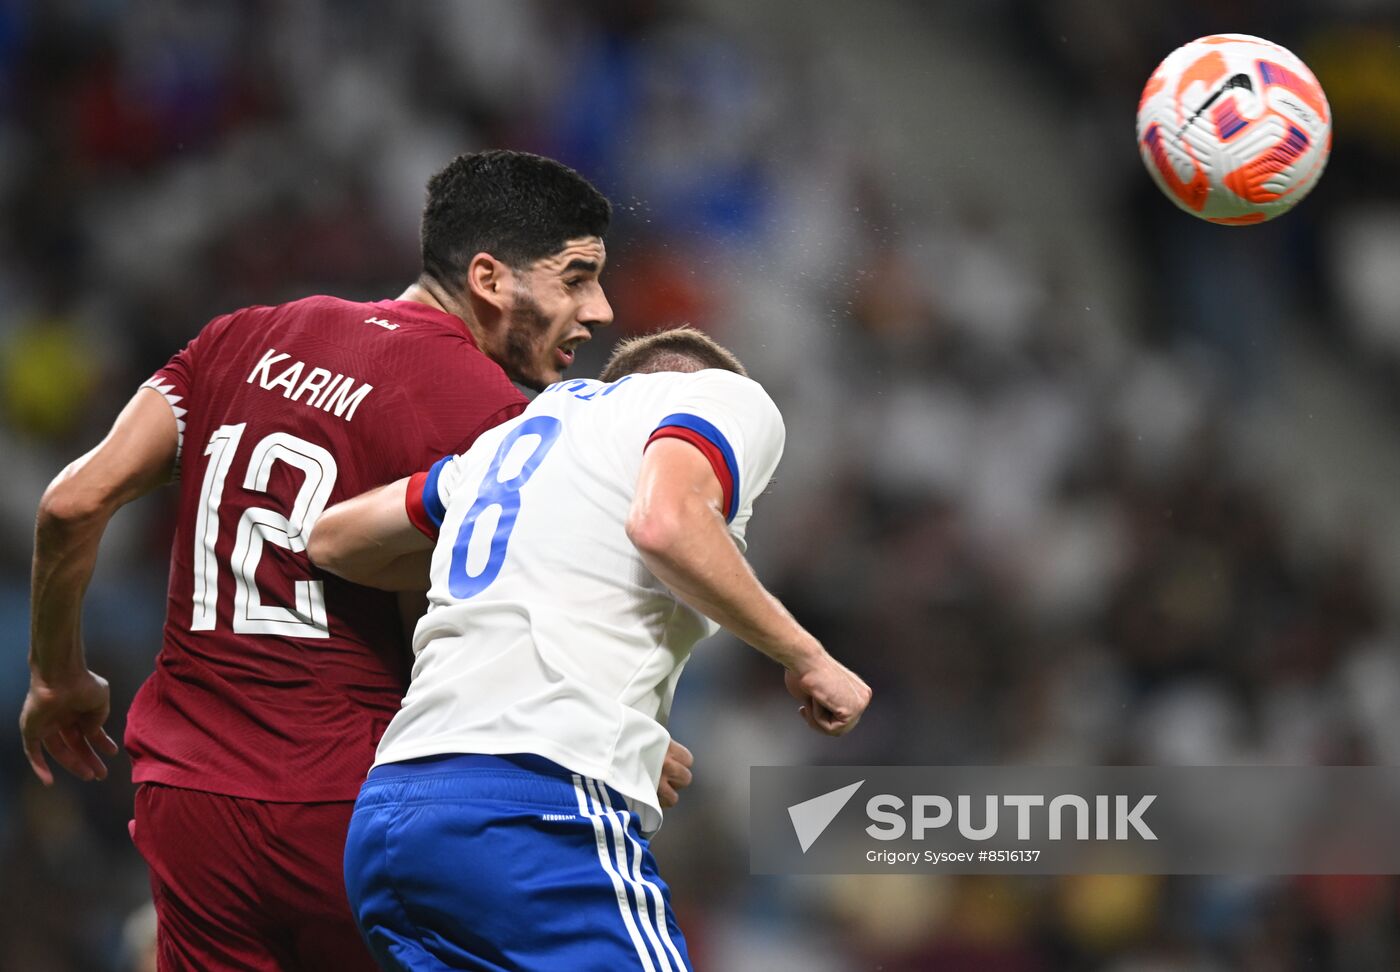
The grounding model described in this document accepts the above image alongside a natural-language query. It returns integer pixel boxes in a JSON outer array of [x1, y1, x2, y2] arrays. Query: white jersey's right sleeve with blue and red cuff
[[647, 370, 785, 524]]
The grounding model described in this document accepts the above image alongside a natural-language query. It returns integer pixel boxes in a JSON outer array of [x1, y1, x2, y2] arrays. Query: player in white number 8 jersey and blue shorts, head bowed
[[308, 329, 869, 972]]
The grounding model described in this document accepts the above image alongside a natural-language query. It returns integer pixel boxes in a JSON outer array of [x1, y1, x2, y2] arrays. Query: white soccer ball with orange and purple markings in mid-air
[[1138, 34, 1331, 225]]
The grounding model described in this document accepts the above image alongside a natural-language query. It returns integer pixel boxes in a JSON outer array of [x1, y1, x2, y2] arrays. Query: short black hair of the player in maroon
[[420, 150, 612, 293]]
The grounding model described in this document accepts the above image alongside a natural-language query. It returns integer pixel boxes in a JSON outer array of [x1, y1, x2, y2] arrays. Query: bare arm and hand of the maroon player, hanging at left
[[20, 388, 179, 784]]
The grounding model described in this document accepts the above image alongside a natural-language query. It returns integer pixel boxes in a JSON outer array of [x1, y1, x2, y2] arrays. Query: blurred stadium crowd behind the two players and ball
[[0, 0, 1400, 972]]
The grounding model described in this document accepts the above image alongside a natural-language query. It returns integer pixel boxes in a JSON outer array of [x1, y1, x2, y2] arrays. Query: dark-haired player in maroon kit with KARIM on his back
[[20, 151, 689, 972]]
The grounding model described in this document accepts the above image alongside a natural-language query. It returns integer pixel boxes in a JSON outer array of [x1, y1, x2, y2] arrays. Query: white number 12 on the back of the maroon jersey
[[189, 423, 337, 637]]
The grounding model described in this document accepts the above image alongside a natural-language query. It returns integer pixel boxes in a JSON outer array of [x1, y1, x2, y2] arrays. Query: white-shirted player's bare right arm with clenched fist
[[627, 438, 871, 735]]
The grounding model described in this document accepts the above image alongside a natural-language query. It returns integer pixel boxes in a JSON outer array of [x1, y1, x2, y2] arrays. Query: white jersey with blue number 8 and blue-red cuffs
[[375, 370, 784, 833]]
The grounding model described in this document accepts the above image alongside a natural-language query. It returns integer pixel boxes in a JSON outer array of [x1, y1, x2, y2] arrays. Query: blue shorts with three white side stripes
[[346, 755, 690, 972]]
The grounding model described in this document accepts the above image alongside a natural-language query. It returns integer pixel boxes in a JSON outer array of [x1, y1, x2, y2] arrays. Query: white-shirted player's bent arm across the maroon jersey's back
[[307, 479, 433, 591]]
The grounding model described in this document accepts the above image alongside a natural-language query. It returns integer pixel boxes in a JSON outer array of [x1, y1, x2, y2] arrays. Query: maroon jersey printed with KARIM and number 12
[[126, 297, 525, 803]]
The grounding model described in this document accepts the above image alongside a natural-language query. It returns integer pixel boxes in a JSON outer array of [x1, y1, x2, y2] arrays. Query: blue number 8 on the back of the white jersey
[[447, 415, 564, 601]]
